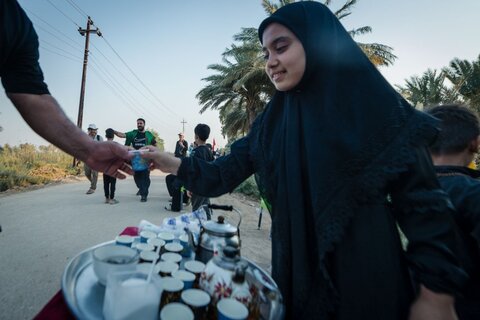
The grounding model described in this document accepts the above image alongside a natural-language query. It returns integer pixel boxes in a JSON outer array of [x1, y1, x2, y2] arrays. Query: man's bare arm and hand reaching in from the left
[[8, 93, 133, 179]]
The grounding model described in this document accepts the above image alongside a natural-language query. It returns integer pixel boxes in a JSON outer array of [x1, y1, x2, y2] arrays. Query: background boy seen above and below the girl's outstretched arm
[[188, 123, 214, 220]]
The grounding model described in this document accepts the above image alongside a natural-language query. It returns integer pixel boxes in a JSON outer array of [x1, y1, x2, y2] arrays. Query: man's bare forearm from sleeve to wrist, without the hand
[[7, 93, 94, 161]]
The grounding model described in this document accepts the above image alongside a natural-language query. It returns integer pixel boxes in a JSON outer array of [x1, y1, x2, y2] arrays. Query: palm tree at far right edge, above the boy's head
[[443, 55, 480, 112]]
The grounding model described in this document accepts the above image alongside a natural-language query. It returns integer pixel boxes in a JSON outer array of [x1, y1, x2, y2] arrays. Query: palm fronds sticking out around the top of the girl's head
[[262, 0, 397, 66]]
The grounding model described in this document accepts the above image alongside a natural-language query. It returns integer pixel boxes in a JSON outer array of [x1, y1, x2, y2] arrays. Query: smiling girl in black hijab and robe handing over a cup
[[142, 1, 468, 320]]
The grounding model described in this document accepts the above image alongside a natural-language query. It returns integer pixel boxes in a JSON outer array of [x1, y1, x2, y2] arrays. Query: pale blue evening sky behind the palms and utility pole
[[0, 0, 480, 151]]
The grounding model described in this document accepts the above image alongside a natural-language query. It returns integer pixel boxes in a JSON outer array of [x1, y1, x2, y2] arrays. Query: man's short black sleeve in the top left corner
[[0, 0, 49, 94]]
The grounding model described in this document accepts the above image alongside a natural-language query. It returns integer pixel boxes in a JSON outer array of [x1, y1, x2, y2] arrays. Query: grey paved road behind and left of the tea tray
[[0, 174, 271, 320]]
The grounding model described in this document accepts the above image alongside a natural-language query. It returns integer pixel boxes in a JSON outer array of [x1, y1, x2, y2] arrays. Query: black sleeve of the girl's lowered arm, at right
[[391, 148, 468, 294]]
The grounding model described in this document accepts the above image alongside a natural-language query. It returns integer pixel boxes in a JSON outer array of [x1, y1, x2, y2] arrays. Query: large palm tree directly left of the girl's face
[[196, 28, 274, 137]]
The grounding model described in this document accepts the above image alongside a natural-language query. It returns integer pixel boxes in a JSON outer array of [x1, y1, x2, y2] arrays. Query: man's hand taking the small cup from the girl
[[85, 141, 133, 179]]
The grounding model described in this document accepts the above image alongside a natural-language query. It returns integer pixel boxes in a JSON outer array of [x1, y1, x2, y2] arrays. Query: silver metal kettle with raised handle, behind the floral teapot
[[187, 204, 242, 263]]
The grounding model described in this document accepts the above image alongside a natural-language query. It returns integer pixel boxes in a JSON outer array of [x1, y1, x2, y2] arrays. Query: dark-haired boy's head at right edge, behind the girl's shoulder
[[426, 104, 480, 156]]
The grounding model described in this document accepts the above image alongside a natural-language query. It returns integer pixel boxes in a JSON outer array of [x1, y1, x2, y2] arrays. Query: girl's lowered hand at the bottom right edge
[[409, 285, 458, 320]]
